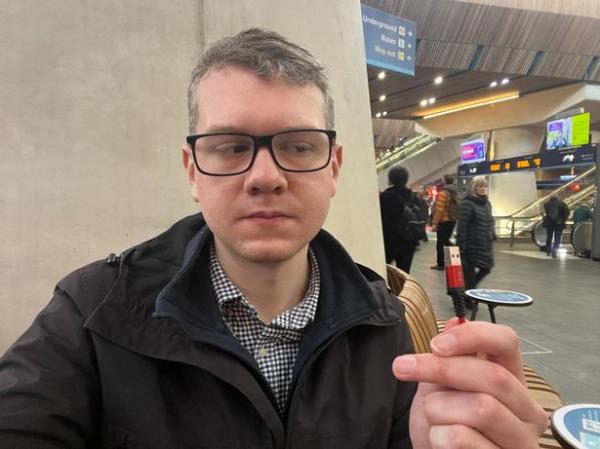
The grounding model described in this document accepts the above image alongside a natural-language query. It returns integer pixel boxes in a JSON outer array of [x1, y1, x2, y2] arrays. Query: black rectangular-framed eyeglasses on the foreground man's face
[[186, 129, 336, 176]]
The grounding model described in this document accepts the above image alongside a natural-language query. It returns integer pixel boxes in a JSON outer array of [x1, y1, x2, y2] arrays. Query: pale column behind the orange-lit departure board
[[489, 127, 544, 216]]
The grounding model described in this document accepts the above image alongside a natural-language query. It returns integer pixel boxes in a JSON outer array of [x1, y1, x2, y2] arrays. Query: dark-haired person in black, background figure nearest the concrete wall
[[379, 167, 426, 273]]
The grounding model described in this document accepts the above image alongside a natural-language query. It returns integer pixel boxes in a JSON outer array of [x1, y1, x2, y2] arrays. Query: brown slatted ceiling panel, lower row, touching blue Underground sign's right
[[417, 40, 477, 70]]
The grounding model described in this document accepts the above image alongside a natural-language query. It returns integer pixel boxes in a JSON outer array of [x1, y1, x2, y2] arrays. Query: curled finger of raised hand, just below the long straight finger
[[424, 391, 539, 449]]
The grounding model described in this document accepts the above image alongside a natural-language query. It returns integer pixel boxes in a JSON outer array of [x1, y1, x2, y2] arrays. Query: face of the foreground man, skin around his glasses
[[183, 66, 342, 263]]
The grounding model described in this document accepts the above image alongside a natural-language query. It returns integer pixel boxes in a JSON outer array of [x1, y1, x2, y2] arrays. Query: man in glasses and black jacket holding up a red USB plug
[[0, 29, 546, 449]]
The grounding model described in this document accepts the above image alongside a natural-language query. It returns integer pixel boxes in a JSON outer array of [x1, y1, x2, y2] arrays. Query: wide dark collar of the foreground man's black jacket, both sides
[[85, 214, 402, 346]]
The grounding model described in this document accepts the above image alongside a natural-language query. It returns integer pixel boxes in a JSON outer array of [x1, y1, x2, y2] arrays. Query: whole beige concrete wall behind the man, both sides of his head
[[0, 0, 384, 353]]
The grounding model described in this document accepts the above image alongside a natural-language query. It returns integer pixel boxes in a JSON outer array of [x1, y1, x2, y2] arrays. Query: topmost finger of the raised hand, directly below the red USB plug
[[431, 320, 525, 383]]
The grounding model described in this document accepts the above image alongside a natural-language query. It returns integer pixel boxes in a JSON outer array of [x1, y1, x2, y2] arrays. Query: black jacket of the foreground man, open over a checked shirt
[[0, 215, 415, 449]]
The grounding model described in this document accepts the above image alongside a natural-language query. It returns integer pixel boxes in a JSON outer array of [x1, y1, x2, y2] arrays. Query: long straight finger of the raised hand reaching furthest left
[[392, 354, 545, 422]]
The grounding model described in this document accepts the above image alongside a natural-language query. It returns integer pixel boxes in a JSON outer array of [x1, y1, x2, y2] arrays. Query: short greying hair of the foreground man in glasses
[[188, 28, 335, 134]]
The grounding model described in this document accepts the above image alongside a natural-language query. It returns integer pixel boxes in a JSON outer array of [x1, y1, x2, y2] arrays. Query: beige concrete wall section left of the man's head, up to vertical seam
[[0, 0, 199, 353]]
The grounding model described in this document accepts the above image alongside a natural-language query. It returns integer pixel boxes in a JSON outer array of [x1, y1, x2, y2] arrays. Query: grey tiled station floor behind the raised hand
[[411, 241, 600, 403]]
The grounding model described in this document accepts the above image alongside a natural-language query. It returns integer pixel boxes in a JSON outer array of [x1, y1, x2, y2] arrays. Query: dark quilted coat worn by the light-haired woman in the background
[[456, 195, 495, 268]]
